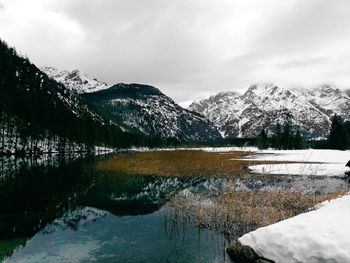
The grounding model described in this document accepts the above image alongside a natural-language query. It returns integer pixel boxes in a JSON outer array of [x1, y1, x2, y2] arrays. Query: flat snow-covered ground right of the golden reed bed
[[243, 150, 350, 176]]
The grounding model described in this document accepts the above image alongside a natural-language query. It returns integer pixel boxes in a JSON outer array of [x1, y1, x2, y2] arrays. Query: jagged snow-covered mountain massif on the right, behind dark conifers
[[189, 84, 350, 138]]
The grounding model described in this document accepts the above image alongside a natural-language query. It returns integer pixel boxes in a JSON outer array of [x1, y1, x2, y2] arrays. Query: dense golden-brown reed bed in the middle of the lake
[[96, 150, 252, 177]]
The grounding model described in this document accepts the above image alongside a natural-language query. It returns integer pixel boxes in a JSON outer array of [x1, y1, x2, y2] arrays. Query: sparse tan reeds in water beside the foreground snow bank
[[169, 189, 347, 237]]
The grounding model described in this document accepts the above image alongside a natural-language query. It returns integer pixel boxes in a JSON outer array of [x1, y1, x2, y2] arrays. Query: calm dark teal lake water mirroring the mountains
[[0, 154, 349, 262]]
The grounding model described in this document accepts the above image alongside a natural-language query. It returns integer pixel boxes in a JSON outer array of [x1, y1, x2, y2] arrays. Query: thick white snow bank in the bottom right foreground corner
[[238, 194, 350, 263]]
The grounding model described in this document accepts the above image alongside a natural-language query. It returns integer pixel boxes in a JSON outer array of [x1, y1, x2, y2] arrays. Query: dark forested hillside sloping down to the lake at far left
[[0, 41, 157, 154]]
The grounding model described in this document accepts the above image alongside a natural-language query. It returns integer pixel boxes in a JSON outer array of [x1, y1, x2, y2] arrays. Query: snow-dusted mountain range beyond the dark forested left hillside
[[42, 67, 350, 141]]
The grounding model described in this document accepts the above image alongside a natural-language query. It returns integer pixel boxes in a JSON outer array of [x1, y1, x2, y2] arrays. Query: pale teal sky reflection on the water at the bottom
[[5, 208, 230, 262]]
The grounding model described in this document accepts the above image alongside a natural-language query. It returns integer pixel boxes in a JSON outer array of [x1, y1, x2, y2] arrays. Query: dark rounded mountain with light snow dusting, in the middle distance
[[82, 83, 221, 141]]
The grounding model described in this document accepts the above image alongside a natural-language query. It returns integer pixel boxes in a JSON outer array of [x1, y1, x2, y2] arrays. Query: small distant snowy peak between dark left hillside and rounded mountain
[[40, 67, 109, 94]]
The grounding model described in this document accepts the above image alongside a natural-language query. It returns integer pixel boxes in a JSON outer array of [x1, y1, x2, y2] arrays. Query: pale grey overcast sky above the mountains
[[0, 0, 350, 105]]
